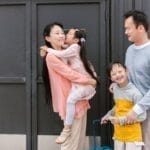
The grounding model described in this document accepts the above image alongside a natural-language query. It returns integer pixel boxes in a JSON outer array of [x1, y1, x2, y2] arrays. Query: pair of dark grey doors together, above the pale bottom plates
[[0, 0, 108, 150]]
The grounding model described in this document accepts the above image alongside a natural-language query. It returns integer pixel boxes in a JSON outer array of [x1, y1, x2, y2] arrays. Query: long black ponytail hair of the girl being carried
[[74, 29, 100, 83]]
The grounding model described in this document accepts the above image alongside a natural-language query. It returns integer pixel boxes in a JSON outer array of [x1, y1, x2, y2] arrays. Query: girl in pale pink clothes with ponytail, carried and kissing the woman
[[43, 29, 98, 144]]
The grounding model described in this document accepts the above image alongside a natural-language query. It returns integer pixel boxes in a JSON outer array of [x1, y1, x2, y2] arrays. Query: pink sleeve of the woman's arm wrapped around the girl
[[46, 53, 89, 84]]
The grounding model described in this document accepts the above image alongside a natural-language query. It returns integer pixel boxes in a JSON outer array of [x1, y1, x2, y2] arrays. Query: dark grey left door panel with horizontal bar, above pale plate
[[0, 3, 26, 134]]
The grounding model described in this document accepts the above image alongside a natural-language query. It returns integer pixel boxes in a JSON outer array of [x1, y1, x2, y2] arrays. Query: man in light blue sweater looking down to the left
[[124, 10, 150, 150]]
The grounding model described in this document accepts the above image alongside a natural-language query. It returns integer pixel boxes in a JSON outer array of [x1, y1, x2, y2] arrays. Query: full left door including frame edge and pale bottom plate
[[0, 0, 31, 150]]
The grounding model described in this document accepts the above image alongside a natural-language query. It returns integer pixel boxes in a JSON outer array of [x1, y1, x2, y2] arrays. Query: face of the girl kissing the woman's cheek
[[65, 29, 77, 45]]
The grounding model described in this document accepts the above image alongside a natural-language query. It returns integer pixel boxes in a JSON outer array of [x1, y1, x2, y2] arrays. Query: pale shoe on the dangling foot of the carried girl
[[55, 129, 71, 144]]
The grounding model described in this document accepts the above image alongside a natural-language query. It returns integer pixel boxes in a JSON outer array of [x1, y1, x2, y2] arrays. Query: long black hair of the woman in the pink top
[[42, 22, 63, 105]]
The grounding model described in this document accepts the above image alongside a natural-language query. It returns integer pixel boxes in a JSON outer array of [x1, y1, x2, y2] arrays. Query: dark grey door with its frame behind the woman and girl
[[32, 0, 109, 149]]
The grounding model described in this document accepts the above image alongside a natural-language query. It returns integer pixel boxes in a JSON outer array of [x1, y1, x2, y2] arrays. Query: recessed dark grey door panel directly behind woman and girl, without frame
[[33, 1, 105, 135]]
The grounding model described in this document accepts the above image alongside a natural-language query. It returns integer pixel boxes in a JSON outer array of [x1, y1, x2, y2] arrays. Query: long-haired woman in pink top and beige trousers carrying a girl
[[41, 23, 95, 150]]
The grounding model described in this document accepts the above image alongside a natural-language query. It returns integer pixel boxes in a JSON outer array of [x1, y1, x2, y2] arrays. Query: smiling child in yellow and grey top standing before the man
[[101, 62, 146, 150]]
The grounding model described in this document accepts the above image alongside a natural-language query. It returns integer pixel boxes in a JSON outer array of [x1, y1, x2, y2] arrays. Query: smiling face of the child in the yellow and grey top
[[110, 64, 128, 86]]
